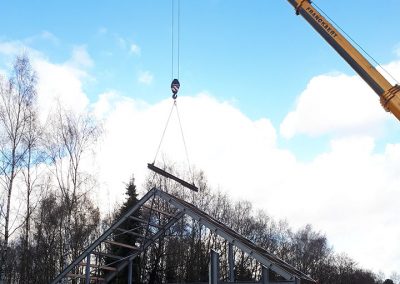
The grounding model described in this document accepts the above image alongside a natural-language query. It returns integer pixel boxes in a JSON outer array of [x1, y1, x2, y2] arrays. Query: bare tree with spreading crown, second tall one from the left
[[44, 106, 101, 269]]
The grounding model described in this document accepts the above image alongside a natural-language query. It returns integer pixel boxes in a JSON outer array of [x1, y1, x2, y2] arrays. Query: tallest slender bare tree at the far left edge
[[0, 56, 36, 282]]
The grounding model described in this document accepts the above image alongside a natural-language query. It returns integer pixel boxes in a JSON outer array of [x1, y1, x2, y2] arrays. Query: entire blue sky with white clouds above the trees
[[0, 0, 400, 275]]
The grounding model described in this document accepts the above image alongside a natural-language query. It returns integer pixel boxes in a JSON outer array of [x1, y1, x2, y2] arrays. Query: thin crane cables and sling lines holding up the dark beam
[[153, 0, 194, 184]]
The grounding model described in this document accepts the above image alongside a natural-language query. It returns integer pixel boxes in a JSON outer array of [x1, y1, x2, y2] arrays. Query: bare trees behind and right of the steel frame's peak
[[129, 171, 400, 284]]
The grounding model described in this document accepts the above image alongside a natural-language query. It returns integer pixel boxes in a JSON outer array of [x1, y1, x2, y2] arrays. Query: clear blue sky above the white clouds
[[0, 0, 399, 159]]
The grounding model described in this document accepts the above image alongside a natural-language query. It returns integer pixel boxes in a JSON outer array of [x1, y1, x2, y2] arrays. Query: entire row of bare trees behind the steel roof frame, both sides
[[0, 56, 400, 284]]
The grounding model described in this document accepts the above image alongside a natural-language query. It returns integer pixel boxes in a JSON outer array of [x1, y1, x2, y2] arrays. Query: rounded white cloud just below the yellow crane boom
[[280, 74, 391, 138]]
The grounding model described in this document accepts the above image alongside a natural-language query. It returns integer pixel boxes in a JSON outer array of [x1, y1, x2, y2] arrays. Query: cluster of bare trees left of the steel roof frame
[[0, 55, 101, 283]]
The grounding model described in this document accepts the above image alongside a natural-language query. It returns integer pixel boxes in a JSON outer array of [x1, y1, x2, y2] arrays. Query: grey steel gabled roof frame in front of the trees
[[51, 188, 316, 284]]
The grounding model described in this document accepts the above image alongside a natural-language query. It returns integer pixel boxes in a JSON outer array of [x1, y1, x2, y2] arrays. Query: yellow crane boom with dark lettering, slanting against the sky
[[288, 0, 400, 120]]
